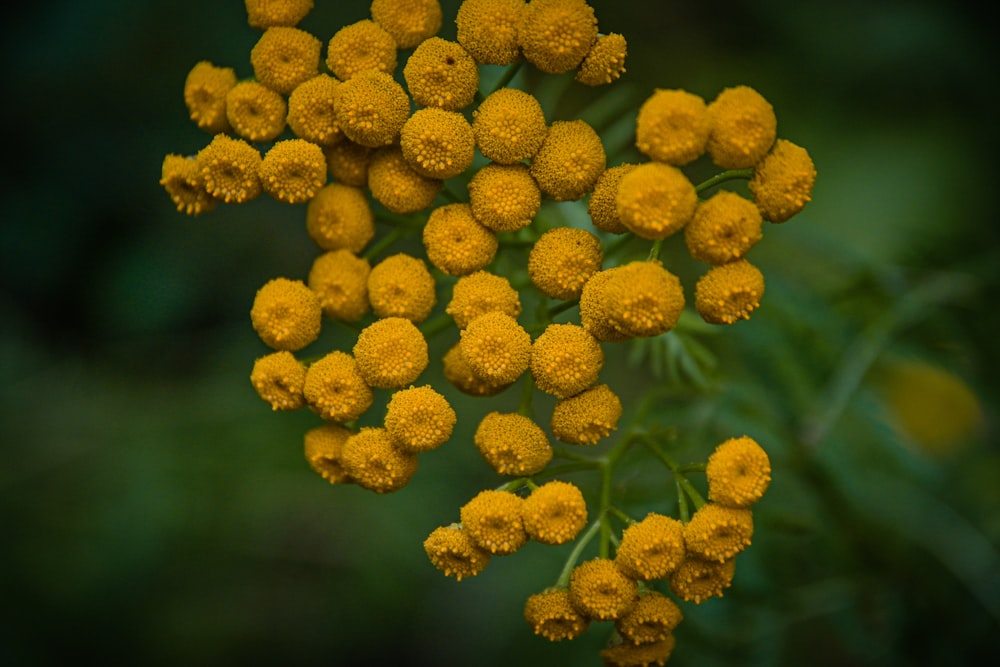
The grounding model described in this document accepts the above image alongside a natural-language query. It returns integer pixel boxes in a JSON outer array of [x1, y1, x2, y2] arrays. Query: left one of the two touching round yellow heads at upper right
[[635, 88, 712, 166]]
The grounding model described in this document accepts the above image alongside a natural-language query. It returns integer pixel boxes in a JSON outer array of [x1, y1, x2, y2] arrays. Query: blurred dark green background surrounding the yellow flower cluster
[[0, 0, 1000, 667]]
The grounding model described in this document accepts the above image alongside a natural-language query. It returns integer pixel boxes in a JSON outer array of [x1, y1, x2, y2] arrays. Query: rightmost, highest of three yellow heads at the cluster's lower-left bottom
[[385, 385, 458, 454]]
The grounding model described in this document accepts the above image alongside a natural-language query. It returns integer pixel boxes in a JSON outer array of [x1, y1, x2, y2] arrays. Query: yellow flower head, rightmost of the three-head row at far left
[[260, 139, 326, 204]]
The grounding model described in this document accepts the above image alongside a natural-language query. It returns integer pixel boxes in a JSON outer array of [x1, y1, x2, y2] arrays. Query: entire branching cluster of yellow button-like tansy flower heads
[[161, 0, 816, 665]]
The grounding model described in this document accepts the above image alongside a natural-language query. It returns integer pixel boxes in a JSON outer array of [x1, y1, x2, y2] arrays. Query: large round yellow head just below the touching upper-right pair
[[615, 162, 698, 240]]
